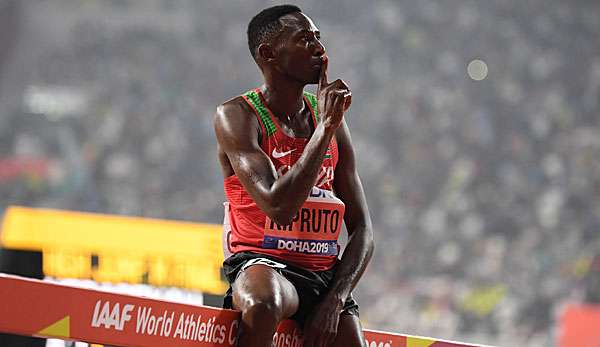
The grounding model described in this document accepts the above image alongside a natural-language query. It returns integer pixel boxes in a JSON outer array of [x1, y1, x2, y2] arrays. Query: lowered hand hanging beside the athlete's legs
[[304, 296, 344, 347]]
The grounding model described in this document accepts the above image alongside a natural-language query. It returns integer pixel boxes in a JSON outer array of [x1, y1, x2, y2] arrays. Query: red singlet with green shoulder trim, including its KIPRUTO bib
[[223, 89, 344, 271]]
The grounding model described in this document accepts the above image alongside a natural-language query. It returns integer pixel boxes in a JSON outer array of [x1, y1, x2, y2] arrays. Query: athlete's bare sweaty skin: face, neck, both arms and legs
[[214, 13, 374, 347]]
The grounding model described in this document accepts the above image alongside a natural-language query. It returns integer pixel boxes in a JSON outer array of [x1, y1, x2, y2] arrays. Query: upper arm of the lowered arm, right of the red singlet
[[334, 121, 371, 237]]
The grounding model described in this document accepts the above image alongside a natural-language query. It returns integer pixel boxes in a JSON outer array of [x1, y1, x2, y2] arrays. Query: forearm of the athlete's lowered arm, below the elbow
[[327, 226, 375, 303]]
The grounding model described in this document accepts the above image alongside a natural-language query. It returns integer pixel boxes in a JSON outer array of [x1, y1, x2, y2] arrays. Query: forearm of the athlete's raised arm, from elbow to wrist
[[269, 124, 334, 224]]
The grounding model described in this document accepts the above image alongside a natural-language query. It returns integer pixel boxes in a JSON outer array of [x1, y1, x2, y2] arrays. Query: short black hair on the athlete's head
[[248, 5, 302, 59]]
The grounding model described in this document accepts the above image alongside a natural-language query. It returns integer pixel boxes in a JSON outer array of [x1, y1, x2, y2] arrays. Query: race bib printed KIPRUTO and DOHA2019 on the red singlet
[[262, 187, 345, 256]]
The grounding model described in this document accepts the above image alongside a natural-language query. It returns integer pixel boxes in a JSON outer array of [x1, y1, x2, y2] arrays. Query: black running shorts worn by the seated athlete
[[223, 252, 359, 327]]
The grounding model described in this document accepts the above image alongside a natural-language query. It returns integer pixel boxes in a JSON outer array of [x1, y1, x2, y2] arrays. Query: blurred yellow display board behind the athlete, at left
[[0, 206, 228, 294]]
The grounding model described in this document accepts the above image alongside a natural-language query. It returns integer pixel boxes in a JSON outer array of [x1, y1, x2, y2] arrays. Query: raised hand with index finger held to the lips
[[317, 57, 352, 130]]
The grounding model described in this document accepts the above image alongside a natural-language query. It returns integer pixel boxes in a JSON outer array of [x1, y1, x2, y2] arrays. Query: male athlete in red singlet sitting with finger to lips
[[214, 5, 373, 347]]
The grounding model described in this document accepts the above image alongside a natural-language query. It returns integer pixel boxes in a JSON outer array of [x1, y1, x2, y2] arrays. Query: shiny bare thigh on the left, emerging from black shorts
[[231, 264, 299, 318]]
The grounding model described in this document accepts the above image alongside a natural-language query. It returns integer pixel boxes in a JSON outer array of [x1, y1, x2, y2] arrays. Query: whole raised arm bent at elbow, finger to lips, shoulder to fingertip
[[214, 58, 351, 225]]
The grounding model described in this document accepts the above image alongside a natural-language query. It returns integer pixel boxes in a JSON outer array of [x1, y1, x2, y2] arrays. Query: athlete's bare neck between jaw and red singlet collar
[[261, 70, 304, 119]]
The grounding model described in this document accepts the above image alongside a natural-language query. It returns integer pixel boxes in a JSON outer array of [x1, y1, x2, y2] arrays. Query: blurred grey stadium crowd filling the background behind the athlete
[[0, 0, 600, 346]]
